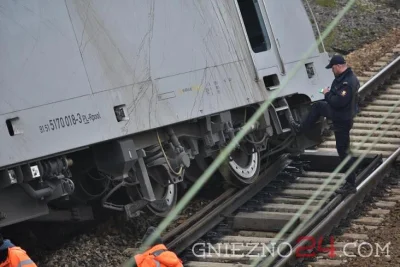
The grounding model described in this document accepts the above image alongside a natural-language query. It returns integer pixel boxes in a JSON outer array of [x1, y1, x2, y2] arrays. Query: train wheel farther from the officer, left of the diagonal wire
[[147, 168, 178, 217]]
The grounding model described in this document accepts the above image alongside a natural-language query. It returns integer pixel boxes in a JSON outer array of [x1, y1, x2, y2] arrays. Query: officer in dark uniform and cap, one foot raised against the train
[[290, 55, 360, 194]]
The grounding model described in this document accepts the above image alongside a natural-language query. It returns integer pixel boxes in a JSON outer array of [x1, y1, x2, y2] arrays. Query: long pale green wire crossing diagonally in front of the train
[[119, 0, 362, 266]]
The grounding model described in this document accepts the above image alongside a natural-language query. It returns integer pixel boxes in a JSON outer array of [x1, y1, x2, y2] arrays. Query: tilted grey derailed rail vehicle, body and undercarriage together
[[0, 0, 333, 226]]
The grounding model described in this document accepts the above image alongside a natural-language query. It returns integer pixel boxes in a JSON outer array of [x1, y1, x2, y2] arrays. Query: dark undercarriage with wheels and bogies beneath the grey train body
[[0, 95, 322, 226]]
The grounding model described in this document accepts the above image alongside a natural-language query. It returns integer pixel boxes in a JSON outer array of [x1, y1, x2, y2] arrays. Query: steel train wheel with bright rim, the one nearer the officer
[[219, 143, 260, 187]]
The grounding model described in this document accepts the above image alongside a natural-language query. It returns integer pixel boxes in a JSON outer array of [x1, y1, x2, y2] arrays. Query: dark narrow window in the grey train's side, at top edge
[[237, 0, 271, 53]]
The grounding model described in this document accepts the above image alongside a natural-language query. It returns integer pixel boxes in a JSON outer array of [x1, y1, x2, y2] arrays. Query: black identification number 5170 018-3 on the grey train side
[[39, 112, 101, 133]]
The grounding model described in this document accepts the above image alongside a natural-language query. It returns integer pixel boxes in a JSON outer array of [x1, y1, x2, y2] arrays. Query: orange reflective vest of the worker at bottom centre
[[135, 244, 183, 267]]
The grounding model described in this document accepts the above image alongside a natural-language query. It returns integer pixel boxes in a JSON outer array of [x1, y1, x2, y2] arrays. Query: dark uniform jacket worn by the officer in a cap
[[325, 68, 360, 121]]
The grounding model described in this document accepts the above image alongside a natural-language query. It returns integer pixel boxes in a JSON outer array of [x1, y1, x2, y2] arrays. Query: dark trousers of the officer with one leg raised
[[302, 101, 356, 185]]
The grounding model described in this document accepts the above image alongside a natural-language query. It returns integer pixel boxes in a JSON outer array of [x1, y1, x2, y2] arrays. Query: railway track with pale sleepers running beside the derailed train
[[122, 45, 400, 267]]
